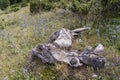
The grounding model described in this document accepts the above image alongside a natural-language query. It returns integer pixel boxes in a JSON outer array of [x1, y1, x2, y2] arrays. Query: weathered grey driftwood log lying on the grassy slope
[[30, 27, 106, 69]]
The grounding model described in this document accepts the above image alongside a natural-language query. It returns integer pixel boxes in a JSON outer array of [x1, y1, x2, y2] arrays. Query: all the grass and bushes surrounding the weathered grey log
[[0, 0, 120, 80]]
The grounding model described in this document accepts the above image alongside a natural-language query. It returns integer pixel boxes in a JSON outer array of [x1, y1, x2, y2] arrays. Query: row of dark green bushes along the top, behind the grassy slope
[[30, 0, 120, 16]]
